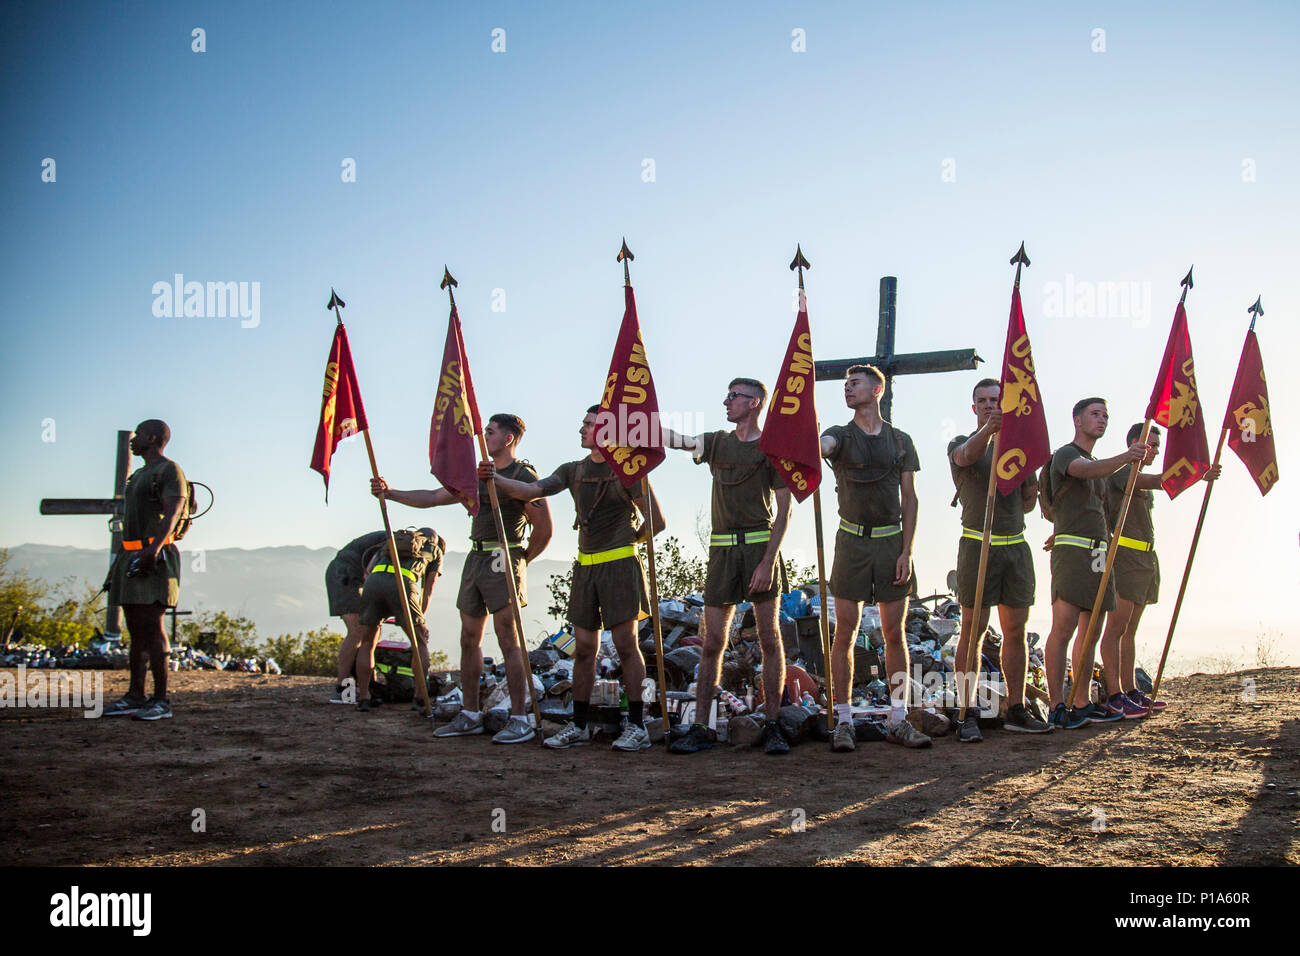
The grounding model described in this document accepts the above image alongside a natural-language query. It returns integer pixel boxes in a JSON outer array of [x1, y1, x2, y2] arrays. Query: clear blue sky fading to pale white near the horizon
[[0, 3, 1300, 671]]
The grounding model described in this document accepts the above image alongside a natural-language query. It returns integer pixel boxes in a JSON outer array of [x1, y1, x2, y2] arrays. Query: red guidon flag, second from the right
[[1147, 302, 1210, 498]]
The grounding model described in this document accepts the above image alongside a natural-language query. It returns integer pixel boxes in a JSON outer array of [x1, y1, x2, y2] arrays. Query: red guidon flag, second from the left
[[429, 303, 482, 515]]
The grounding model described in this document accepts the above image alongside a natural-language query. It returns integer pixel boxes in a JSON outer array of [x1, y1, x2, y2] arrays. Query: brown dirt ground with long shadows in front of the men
[[0, 669, 1300, 865]]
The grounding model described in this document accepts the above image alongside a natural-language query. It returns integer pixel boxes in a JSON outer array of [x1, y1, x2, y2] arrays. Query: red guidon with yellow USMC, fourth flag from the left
[[758, 290, 822, 501]]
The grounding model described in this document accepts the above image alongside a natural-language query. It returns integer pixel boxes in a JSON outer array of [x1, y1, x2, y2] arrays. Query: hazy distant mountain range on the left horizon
[[8, 545, 569, 659]]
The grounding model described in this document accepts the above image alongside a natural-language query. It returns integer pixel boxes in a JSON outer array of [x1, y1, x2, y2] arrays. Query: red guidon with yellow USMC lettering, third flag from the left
[[593, 286, 664, 488]]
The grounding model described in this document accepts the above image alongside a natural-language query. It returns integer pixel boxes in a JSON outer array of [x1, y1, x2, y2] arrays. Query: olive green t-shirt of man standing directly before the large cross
[[823, 421, 920, 528]]
